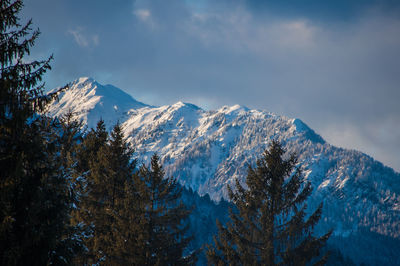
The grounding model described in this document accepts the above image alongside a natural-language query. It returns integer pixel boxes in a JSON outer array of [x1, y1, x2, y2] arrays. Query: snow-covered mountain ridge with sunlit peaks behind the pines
[[49, 78, 400, 265]]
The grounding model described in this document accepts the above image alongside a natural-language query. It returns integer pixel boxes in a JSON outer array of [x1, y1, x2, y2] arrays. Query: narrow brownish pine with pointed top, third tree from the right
[[92, 124, 135, 265]]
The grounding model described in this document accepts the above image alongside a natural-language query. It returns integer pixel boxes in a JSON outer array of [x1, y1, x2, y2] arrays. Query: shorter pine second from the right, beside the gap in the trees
[[134, 154, 197, 265]]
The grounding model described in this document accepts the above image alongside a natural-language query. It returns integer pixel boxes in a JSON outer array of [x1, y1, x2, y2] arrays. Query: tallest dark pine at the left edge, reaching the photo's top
[[0, 0, 79, 265]]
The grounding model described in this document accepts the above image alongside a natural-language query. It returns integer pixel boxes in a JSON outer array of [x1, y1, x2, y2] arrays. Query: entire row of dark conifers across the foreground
[[0, 0, 331, 265]]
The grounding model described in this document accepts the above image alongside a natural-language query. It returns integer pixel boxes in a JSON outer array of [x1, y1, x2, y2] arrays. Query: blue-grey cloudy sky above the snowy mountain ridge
[[21, 0, 400, 171]]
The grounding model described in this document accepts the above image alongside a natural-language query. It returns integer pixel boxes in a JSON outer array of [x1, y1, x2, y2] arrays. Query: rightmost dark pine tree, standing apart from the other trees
[[207, 141, 331, 265]]
